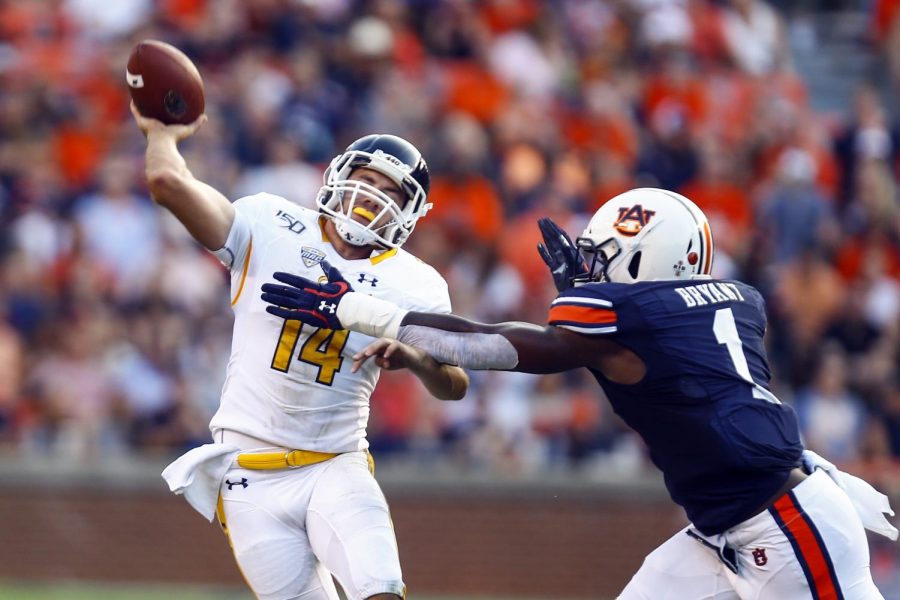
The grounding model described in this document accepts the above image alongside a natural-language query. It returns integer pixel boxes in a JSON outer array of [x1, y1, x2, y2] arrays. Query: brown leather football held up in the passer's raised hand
[[125, 40, 204, 125]]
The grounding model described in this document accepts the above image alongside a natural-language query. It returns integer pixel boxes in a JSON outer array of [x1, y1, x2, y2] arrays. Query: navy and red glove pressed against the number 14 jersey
[[261, 260, 353, 329]]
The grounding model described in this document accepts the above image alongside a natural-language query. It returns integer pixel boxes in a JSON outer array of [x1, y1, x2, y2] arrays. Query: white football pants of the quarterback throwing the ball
[[220, 452, 405, 600]]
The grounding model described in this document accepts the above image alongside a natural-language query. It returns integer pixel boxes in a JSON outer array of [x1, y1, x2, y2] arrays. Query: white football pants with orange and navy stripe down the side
[[619, 470, 883, 600]]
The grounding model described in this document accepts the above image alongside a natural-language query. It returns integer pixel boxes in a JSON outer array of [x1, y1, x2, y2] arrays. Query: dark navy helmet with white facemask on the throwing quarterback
[[316, 134, 431, 248]]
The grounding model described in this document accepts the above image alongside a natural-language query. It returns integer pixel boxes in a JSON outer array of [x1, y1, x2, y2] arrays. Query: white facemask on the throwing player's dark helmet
[[317, 150, 431, 248]]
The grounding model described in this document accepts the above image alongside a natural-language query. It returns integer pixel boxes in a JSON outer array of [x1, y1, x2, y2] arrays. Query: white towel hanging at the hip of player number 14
[[162, 444, 241, 521]]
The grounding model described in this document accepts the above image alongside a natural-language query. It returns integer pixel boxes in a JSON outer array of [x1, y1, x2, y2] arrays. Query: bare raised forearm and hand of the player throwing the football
[[131, 103, 234, 250]]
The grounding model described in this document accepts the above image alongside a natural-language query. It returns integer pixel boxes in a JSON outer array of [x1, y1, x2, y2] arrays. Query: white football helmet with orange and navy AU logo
[[575, 188, 713, 284]]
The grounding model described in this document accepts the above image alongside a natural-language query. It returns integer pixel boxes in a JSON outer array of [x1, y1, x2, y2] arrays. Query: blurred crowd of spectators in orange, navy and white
[[0, 0, 900, 568]]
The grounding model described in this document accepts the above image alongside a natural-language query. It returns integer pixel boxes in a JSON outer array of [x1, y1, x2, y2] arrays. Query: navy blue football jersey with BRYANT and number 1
[[549, 279, 803, 535]]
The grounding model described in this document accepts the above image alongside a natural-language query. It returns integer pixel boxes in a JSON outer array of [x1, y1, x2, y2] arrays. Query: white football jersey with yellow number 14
[[210, 194, 450, 452]]
